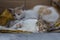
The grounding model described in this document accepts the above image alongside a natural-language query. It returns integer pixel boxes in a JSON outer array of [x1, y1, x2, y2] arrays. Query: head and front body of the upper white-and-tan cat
[[10, 7, 38, 24]]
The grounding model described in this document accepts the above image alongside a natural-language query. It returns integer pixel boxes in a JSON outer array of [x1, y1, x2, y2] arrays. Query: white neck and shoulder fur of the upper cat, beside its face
[[15, 9, 38, 20]]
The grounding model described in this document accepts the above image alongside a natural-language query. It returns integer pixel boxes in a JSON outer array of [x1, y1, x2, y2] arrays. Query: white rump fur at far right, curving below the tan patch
[[42, 7, 59, 23]]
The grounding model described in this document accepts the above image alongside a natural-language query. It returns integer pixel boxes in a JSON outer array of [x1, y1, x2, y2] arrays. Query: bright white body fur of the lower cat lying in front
[[13, 19, 38, 32]]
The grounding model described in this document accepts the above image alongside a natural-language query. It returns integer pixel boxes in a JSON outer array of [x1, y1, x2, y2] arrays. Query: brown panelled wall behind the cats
[[0, 0, 51, 13]]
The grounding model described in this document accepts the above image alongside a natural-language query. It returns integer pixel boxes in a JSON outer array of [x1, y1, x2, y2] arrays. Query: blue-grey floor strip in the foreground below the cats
[[0, 33, 60, 40]]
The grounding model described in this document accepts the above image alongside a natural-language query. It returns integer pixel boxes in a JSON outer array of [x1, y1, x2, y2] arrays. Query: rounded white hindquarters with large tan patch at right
[[35, 7, 59, 23]]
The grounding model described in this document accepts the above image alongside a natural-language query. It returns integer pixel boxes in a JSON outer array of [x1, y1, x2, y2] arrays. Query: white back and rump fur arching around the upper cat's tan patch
[[33, 5, 59, 23]]
